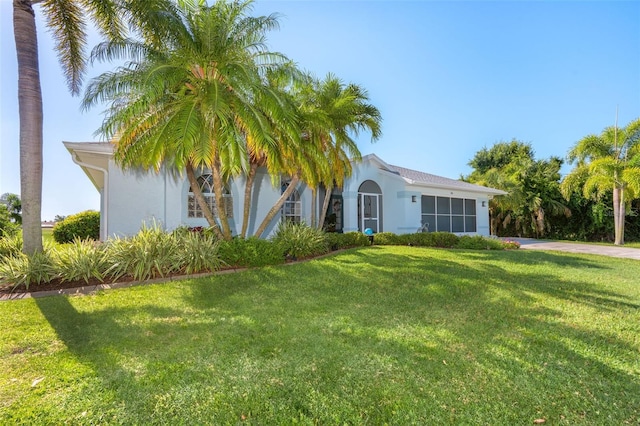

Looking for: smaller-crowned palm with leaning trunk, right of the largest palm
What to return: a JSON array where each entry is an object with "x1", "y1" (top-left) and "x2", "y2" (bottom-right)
[{"x1": 250, "y1": 74, "x2": 382, "y2": 236}]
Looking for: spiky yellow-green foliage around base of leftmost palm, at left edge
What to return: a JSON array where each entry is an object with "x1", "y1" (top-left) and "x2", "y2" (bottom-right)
[{"x1": 0, "y1": 250, "x2": 58, "y2": 290}]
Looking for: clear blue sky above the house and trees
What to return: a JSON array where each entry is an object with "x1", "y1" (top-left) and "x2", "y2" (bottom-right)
[{"x1": 0, "y1": 0, "x2": 640, "y2": 219}]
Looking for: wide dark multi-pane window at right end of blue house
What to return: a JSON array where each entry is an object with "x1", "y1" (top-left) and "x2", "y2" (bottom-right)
[{"x1": 422, "y1": 195, "x2": 476, "y2": 232}]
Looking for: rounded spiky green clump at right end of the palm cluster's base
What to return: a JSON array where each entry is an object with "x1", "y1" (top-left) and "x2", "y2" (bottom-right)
[{"x1": 272, "y1": 221, "x2": 329, "y2": 259}]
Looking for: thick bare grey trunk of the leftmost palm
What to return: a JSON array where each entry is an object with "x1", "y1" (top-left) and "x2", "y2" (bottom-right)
[{"x1": 13, "y1": 0, "x2": 43, "y2": 254}]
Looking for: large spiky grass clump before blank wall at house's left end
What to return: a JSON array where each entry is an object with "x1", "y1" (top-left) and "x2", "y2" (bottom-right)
[{"x1": 105, "y1": 225, "x2": 181, "y2": 280}]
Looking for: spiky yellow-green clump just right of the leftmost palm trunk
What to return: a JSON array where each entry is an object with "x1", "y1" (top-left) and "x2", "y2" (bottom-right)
[{"x1": 54, "y1": 238, "x2": 107, "y2": 284}]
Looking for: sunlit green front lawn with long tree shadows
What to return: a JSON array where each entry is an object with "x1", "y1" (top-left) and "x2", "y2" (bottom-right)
[{"x1": 0, "y1": 246, "x2": 640, "y2": 425}]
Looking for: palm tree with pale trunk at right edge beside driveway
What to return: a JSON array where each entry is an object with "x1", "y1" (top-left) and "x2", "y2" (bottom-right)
[{"x1": 561, "y1": 119, "x2": 640, "y2": 245}]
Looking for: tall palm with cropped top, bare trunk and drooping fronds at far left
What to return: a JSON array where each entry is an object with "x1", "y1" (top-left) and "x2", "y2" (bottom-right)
[{"x1": 13, "y1": 0, "x2": 175, "y2": 253}]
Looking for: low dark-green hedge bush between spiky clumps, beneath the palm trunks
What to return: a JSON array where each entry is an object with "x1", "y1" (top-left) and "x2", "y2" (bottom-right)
[{"x1": 219, "y1": 237, "x2": 284, "y2": 268}]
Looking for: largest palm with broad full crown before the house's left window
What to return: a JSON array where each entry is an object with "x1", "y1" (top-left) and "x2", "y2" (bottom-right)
[{"x1": 84, "y1": 1, "x2": 287, "y2": 239}]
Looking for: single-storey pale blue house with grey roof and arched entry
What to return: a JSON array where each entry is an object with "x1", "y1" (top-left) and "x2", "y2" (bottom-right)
[{"x1": 64, "y1": 142, "x2": 505, "y2": 239}]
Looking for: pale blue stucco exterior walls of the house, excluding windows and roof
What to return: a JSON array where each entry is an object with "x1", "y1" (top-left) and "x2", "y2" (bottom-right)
[{"x1": 102, "y1": 156, "x2": 496, "y2": 237}]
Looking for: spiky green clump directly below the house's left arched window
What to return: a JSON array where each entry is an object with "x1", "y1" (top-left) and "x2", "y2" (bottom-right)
[{"x1": 173, "y1": 232, "x2": 223, "y2": 274}]
